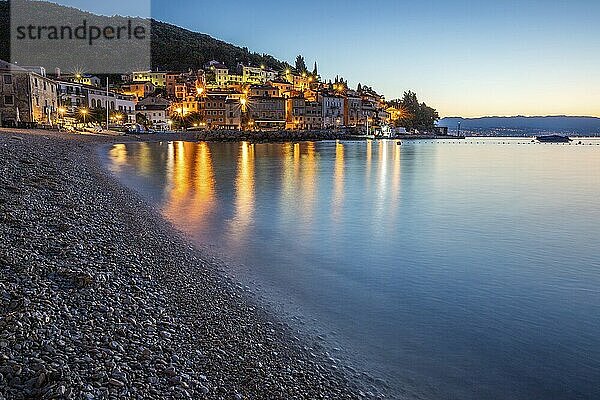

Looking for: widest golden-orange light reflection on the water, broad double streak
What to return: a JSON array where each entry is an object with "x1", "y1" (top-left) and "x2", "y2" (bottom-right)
[{"x1": 163, "y1": 142, "x2": 217, "y2": 230}]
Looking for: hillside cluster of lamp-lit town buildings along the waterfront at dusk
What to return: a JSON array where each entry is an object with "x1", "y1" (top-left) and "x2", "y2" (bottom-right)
[{"x1": 0, "y1": 57, "x2": 400, "y2": 131}]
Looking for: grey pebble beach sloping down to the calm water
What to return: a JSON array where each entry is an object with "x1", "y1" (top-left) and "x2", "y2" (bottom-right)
[{"x1": 0, "y1": 129, "x2": 380, "y2": 399}]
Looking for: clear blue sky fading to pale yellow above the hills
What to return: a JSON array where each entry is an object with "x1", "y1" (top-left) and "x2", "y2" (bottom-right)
[{"x1": 43, "y1": 0, "x2": 600, "y2": 117}]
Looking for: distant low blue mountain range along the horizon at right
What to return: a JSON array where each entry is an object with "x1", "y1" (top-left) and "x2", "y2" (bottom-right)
[{"x1": 438, "y1": 115, "x2": 600, "y2": 136}]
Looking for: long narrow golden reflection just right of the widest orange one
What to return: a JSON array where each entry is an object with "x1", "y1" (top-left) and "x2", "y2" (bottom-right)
[{"x1": 229, "y1": 142, "x2": 256, "y2": 244}]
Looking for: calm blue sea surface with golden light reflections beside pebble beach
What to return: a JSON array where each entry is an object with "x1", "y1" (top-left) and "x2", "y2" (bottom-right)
[{"x1": 106, "y1": 139, "x2": 600, "y2": 400}]
